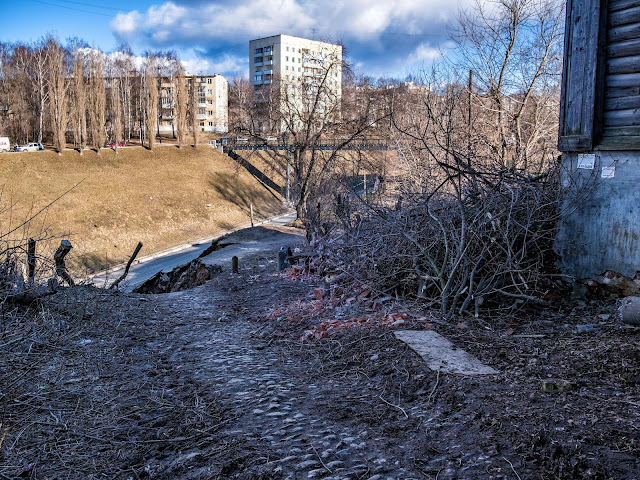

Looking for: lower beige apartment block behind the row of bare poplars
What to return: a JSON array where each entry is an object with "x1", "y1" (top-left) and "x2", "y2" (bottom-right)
[{"x1": 158, "y1": 75, "x2": 229, "y2": 133}]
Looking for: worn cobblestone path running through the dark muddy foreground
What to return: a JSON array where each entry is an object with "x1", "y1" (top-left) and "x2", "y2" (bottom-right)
[{"x1": 148, "y1": 283, "x2": 422, "y2": 480}]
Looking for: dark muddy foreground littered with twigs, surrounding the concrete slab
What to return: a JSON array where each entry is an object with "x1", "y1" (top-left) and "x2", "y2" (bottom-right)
[{"x1": 0, "y1": 229, "x2": 640, "y2": 480}]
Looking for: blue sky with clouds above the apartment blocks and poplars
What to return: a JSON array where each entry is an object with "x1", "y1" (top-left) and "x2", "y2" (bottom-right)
[{"x1": 5, "y1": 0, "x2": 470, "y2": 78}]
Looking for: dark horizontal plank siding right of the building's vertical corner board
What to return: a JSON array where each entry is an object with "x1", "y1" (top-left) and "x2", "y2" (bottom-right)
[{"x1": 602, "y1": 0, "x2": 640, "y2": 141}]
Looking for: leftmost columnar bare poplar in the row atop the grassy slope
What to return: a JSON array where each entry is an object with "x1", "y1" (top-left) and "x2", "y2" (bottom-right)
[{"x1": 46, "y1": 37, "x2": 69, "y2": 155}]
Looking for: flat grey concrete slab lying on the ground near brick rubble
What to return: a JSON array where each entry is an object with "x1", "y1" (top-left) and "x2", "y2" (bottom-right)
[{"x1": 394, "y1": 330, "x2": 498, "y2": 375}]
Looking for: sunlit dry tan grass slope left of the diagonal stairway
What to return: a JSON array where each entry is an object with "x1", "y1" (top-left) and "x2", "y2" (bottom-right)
[{"x1": 0, "y1": 145, "x2": 282, "y2": 271}]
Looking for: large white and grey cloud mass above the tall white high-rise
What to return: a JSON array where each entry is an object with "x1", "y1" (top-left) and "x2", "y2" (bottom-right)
[{"x1": 111, "y1": 0, "x2": 474, "y2": 75}]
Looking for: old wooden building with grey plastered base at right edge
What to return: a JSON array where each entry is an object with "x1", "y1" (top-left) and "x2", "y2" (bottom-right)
[{"x1": 555, "y1": 0, "x2": 640, "y2": 286}]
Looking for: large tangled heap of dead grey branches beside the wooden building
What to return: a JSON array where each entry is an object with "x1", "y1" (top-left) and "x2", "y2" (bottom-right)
[{"x1": 318, "y1": 167, "x2": 559, "y2": 315}]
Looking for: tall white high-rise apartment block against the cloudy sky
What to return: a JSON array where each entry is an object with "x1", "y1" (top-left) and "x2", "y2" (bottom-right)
[{"x1": 249, "y1": 35, "x2": 342, "y2": 130}]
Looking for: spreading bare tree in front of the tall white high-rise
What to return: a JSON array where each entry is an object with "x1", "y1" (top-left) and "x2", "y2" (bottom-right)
[{"x1": 235, "y1": 51, "x2": 389, "y2": 221}]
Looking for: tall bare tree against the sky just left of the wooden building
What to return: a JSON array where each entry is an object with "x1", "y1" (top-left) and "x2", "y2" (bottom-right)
[{"x1": 452, "y1": 0, "x2": 564, "y2": 170}]
